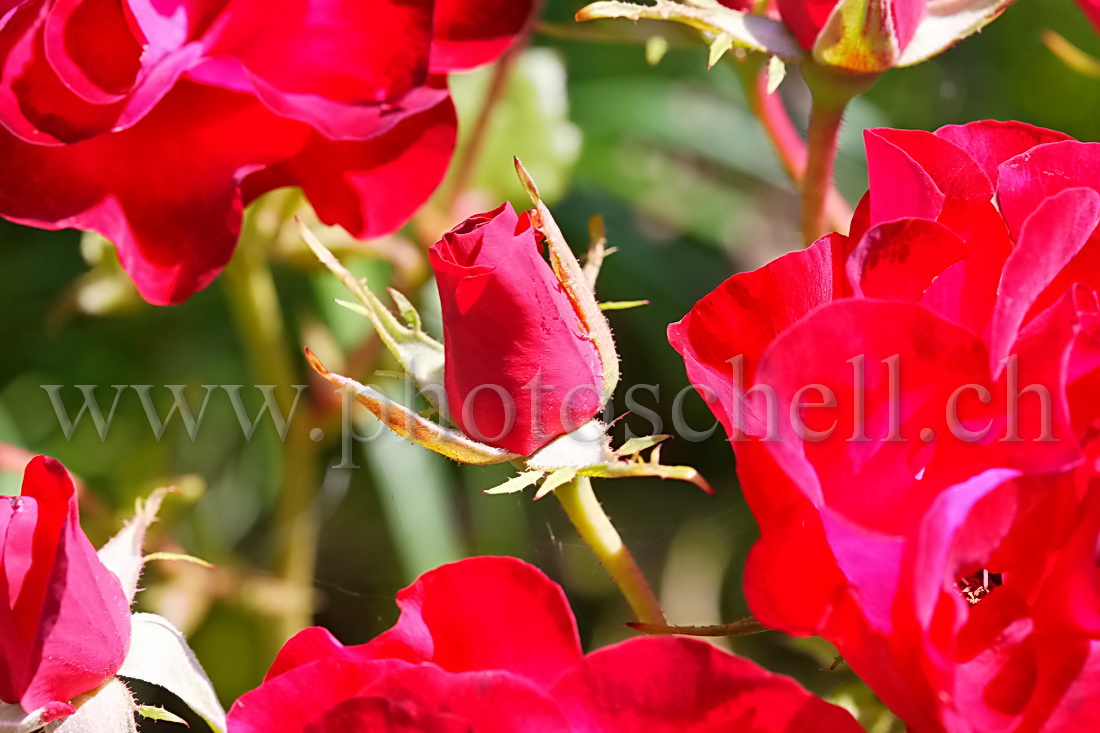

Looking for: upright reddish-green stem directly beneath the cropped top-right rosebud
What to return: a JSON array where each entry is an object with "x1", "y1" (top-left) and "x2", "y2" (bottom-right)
[{"x1": 802, "y1": 64, "x2": 878, "y2": 247}]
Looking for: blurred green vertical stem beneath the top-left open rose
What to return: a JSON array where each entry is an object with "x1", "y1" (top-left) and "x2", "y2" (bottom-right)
[{"x1": 222, "y1": 200, "x2": 317, "y2": 649}]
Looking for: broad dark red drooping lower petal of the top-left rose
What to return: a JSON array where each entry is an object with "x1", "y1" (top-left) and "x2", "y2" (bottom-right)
[{"x1": 0, "y1": 83, "x2": 308, "y2": 304}]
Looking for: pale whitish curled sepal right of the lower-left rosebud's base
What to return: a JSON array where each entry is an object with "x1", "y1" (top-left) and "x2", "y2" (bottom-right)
[{"x1": 118, "y1": 613, "x2": 226, "y2": 733}]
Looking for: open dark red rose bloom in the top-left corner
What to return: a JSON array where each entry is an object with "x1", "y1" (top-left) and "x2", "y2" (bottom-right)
[{"x1": 0, "y1": 0, "x2": 535, "y2": 304}]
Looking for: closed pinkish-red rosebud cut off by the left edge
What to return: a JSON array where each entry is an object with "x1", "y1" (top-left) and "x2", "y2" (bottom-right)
[{"x1": 0, "y1": 457, "x2": 130, "y2": 722}]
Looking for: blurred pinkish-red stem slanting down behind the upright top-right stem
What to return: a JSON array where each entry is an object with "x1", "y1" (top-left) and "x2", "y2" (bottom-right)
[{"x1": 727, "y1": 54, "x2": 851, "y2": 233}]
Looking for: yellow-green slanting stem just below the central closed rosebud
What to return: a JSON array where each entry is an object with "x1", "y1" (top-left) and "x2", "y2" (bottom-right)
[{"x1": 554, "y1": 475, "x2": 666, "y2": 626}]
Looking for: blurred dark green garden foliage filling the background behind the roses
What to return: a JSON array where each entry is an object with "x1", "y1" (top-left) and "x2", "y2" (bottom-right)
[{"x1": 0, "y1": 0, "x2": 1100, "y2": 730}]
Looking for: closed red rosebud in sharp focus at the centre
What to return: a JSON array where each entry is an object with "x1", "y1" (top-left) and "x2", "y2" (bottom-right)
[{"x1": 429, "y1": 204, "x2": 603, "y2": 456}]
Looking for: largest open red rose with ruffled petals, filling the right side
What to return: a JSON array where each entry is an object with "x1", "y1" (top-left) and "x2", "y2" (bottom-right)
[{"x1": 669, "y1": 122, "x2": 1100, "y2": 731}]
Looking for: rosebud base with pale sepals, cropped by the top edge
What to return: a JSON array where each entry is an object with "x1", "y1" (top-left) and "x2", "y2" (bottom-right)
[{"x1": 777, "y1": 0, "x2": 1013, "y2": 73}]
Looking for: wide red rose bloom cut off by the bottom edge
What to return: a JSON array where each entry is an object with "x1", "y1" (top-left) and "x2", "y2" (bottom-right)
[{"x1": 229, "y1": 557, "x2": 860, "y2": 733}]
